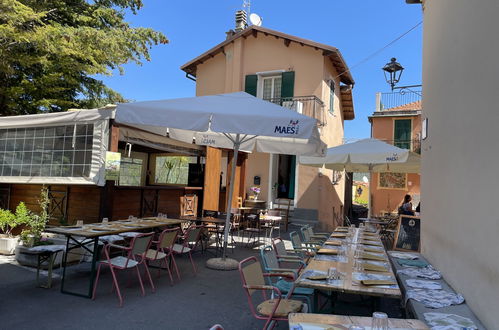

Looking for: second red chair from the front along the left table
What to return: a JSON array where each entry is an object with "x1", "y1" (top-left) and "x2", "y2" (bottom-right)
[{"x1": 145, "y1": 227, "x2": 180, "y2": 285}]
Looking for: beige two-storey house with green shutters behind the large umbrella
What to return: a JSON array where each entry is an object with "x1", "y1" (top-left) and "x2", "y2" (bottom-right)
[{"x1": 181, "y1": 26, "x2": 354, "y2": 227}]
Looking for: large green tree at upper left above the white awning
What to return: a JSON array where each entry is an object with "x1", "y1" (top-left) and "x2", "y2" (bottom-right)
[{"x1": 0, "y1": 0, "x2": 168, "y2": 115}]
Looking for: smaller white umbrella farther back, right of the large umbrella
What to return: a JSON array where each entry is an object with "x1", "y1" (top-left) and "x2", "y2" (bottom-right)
[{"x1": 300, "y1": 139, "x2": 420, "y2": 216}]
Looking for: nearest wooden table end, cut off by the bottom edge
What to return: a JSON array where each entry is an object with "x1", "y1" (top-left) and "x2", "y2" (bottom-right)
[{"x1": 288, "y1": 313, "x2": 429, "y2": 330}]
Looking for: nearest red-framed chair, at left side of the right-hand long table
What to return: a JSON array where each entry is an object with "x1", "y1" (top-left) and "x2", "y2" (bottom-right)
[{"x1": 239, "y1": 257, "x2": 307, "y2": 329}]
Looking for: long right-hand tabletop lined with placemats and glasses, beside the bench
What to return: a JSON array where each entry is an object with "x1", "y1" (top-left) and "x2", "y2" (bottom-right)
[{"x1": 296, "y1": 227, "x2": 401, "y2": 298}]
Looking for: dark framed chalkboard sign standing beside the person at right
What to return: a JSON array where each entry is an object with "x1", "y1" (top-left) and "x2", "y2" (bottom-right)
[{"x1": 393, "y1": 215, "x2": 421, "y2": 252}]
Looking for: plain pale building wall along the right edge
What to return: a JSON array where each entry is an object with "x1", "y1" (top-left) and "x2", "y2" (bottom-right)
[{"x1": 421, "y1": 0, "x2": 499, "y2": 329}]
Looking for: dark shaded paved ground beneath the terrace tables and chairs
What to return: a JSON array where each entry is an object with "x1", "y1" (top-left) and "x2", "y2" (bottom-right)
[{"x1": 0, "y1": 227, "x2": 400, "y2": 330}]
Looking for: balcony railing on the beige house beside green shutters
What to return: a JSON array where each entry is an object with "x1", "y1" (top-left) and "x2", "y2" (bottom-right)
[{"x1": 266, "y1": 95, "x2": 327, "y2": 126}]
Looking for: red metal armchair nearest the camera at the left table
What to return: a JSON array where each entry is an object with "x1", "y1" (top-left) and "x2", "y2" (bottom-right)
[{"x1": 92, "y1": 233, "x2": 155, "y2": 307}]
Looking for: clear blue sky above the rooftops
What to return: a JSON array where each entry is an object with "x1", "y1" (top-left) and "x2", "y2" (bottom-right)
[{"x1": 100, "y1": 0, "x2": 422, "y2": 139}]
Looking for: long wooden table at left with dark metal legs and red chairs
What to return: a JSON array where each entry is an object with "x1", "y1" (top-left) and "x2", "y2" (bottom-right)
[{"x1": 45, "y1": 217, "x2": 184, "y2": 298}]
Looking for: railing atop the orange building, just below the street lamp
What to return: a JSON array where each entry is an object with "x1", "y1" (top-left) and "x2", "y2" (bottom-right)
[{"x1": 376, "y1": 90, "x2": 421, "y2": 111}]
